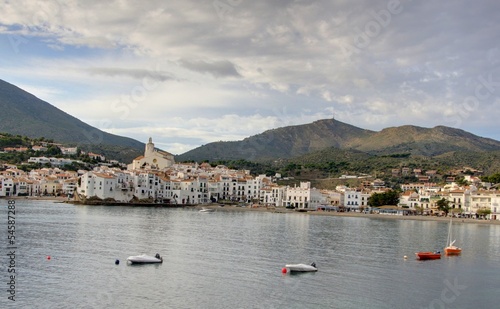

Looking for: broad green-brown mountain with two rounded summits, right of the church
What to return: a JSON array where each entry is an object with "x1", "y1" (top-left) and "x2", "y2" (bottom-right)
[{"x1": 177, "y1": 119, "x2": 500, "y2": 161}]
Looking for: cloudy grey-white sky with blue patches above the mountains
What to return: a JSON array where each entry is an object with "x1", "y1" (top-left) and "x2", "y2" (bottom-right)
[{"x1": 0, "y1": 0, "x2": 500, "y2": 154}]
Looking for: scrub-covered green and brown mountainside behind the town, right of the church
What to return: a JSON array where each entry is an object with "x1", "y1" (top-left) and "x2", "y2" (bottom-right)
[{"x1": 177, "y1": 119, "x2": 500, "y2": 165}]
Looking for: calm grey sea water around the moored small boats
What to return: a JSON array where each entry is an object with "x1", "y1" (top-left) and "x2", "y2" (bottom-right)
[{"x1": 0, "y1": 200, "x2": 500, "y2": 308}]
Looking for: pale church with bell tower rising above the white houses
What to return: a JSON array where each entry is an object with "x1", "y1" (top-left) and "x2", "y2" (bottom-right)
[{"x1": 127, "y1": 137, "x2": 175, "y2": 171}]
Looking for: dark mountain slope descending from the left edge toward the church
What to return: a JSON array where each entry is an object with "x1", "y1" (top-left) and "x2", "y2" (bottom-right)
[{"x1": 0, "y1": 80, "x2": 144, "y2": 161}]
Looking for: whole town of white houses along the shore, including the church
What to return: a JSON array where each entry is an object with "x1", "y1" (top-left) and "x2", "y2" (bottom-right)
[{"x1": 0, "y1": 138, "x2": 500, "y2": 220}]
